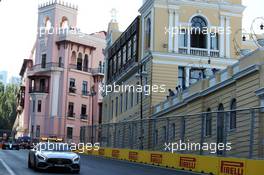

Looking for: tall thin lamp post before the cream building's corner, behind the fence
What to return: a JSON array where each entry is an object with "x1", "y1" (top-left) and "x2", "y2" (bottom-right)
[{"x1": 136, "y1": 64, "x2": 148, "y2": 150}]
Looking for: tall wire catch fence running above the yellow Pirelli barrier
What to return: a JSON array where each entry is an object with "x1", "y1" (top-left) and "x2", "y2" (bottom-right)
[{"x1": 84, "y1": 108, "x2": 264, "y2": 159}]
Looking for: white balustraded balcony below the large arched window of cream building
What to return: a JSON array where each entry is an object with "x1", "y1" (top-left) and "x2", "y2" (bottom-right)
[{"x1": 179, "y1": 47, "x2": 220, "y2": 58}]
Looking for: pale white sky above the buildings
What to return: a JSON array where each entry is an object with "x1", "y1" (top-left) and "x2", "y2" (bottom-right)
[{"x1": 0, "y1": 0, "x2": 264, "y2": 77}]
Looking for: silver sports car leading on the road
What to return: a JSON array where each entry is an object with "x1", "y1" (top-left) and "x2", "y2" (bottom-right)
[{"x1": 28, "y1": 142, "x2": 80, "y2": 174}]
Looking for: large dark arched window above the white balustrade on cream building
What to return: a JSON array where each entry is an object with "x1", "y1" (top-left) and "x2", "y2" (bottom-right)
[{"x1": 191, "y1": 16, "x2": 207, "y2": 49}]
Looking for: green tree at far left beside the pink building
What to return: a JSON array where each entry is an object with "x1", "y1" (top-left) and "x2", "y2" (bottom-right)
[{"x1": 0, "y1": 84, "x2": 19, "y2": 130}]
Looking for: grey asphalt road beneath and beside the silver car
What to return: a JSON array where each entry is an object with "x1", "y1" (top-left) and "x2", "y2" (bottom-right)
[{"x1": 0, "y1": 150, "x2": 202, "y2": 175}]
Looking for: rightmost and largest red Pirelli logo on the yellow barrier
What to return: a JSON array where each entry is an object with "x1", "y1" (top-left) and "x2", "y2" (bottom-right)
[{"x1": 220, "y1": 161, "x2": 245, "y2": 175}]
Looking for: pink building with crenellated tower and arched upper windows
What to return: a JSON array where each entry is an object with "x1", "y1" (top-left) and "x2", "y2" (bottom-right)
[{"x1": 14, "y1": 1, "x2": 106, "y2": 142}]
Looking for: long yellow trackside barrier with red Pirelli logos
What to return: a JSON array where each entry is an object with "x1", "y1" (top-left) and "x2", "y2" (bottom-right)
[{"x1": 76, "y1": 148, "x2": 264, "y2": 175}]
